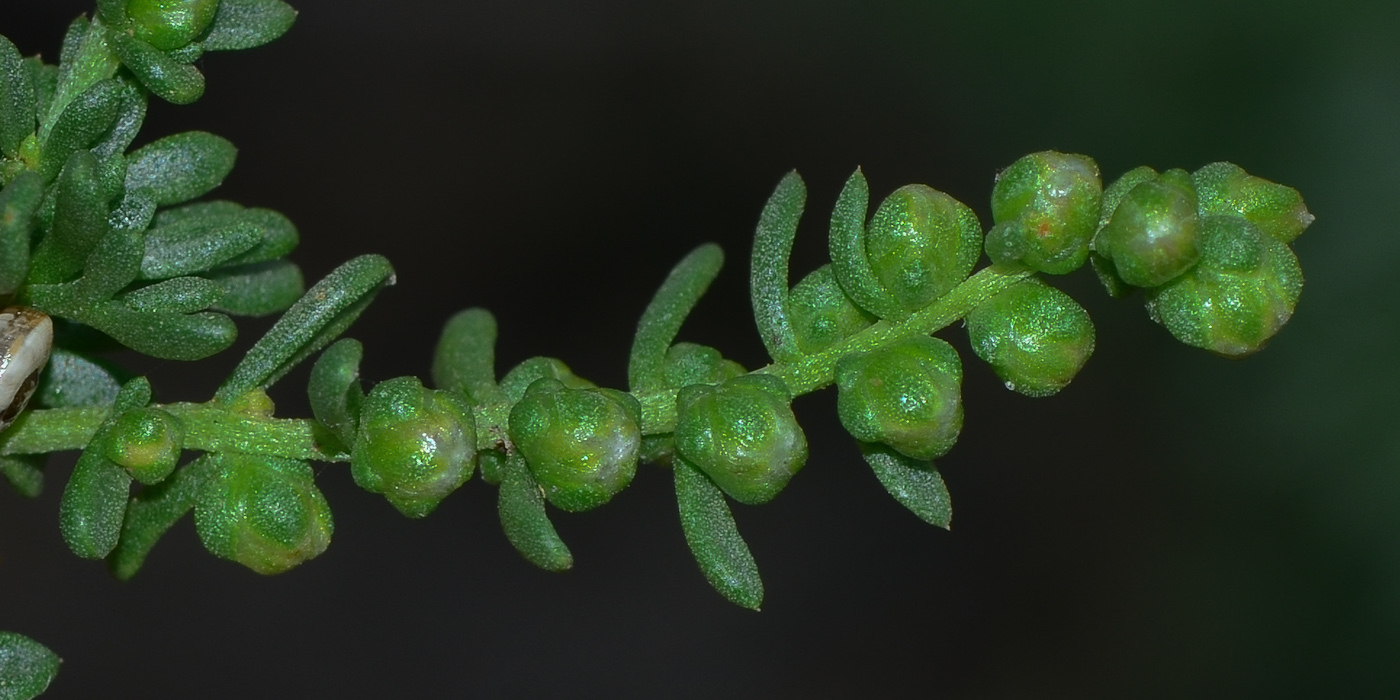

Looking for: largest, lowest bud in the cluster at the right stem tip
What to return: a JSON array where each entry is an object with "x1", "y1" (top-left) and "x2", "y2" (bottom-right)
[{"x1": 1148, "y1": 216, "x2": 1303, "y2": 357}]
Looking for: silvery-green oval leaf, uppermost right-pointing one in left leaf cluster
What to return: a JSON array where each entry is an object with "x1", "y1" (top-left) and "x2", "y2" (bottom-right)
[{"x1": 126, "y1": 132, "x2": 238, "y2": 206}]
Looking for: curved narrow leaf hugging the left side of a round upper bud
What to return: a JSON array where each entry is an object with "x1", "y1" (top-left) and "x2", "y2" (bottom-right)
[{"x1": 827, "y1": 168, "x2": 909, "y2": 319}]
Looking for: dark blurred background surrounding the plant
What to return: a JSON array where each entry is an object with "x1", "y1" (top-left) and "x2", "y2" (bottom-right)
[{"x1": 0, "y1": 0, "x2": 1400, "y2": 699}]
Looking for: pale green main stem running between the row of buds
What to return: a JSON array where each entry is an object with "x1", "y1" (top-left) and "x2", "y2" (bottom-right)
[{"x1": 0, "y1": 266, "x2": 1032, "y2": 462}]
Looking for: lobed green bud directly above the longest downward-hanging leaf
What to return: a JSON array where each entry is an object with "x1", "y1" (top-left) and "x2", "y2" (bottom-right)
[{"x1": 675, "y1": 374, "x2": 806, "y2": 505}]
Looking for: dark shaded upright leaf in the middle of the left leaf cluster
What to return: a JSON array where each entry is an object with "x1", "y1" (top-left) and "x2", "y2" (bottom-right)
[{"x1": 29, "y1": 151, "x2": 107, "y2": 284}]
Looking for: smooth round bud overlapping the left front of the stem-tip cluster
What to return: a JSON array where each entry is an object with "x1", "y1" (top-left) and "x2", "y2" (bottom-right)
[{"x1": 1093, "y1": 169, "x2": 1201, "y2": 287}]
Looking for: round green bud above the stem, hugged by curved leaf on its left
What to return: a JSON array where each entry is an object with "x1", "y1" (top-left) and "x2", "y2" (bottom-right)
[{"x1": 865, "y1": 185, "x2": 981, "y2": 311}]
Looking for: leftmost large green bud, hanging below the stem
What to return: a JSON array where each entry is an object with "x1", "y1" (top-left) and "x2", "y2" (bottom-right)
[{"x1": 195, "y1": 452, "x2": 335, "y2": 574}]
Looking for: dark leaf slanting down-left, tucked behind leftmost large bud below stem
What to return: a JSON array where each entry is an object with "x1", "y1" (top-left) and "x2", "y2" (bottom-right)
[{"x1": 108, "y1": 455, "x2": 218, "y2": 581}]
